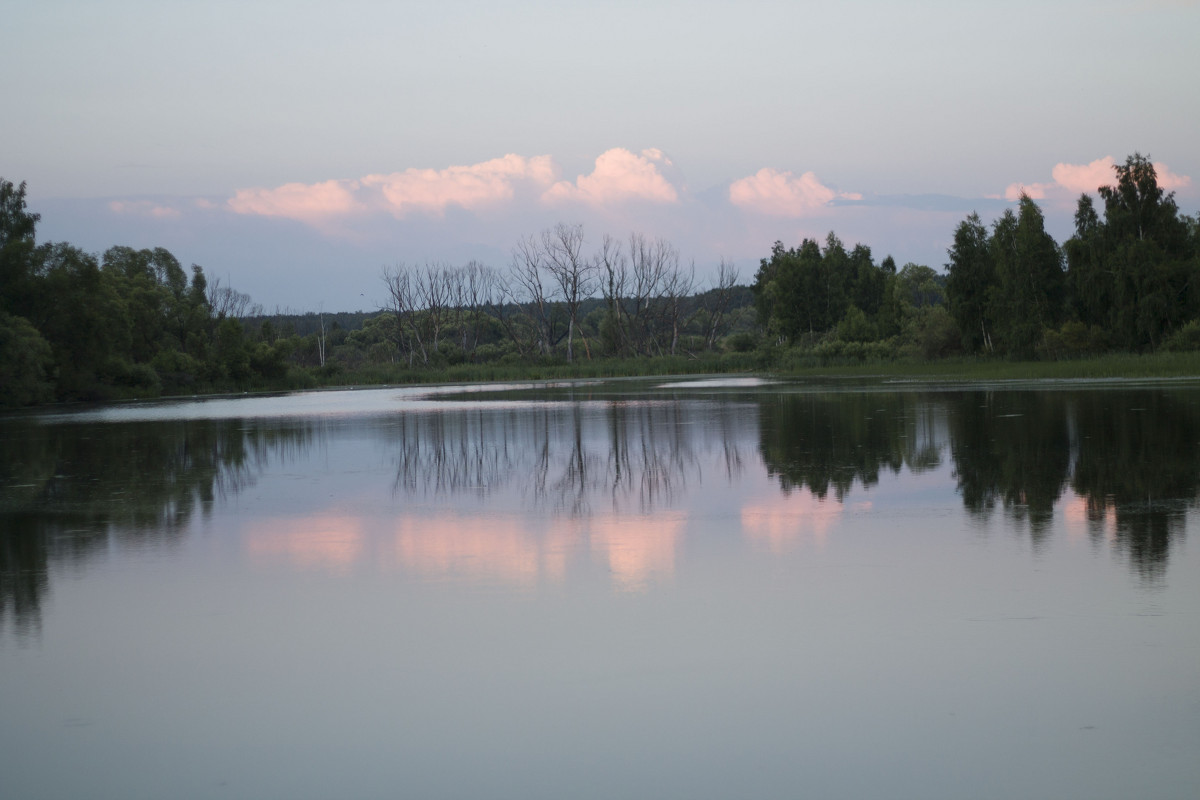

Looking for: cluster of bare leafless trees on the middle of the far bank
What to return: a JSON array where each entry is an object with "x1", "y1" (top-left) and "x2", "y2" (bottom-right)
[{"x1": 374, "y1": 223, "x2": 750, "y2": 366}]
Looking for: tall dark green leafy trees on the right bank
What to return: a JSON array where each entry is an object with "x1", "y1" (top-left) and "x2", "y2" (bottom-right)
[{"x1": 752, "y1": 154, "x2": 1200, "y2": 359}]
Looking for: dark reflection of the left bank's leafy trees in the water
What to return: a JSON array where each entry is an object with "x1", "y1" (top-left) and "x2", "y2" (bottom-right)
[{"x1": 0, "y1": 420, "x2": 313, "y2": 634}]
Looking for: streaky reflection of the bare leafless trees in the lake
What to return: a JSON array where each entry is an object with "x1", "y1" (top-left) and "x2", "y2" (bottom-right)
[{"x1": 394, "y1": 401, "x2": 754, "y2": 516}]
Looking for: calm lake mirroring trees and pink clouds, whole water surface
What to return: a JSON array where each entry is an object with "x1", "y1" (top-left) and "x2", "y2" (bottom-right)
[{"x1": 0, "y1": 378, "x2": 1200, "y2": 800}]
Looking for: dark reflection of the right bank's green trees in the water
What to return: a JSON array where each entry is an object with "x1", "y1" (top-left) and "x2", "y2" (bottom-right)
[{"x1": 760, "y1": 389, "x2": 1200, "y2": 582}]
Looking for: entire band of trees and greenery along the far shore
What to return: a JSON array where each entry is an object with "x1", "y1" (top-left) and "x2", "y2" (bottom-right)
[{"x1": 0, "y1": 154, "x2": 1200, "y2": 408}]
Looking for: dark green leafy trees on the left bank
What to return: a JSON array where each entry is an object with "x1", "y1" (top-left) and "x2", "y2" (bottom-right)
[{"x1": 0, "y1": 179, "x2": 297, "y2": 405}]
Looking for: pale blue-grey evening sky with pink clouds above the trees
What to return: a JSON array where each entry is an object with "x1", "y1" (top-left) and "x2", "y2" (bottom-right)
[{"x1": 0, "y1": 0, "x2": 1200, "y2": 312}]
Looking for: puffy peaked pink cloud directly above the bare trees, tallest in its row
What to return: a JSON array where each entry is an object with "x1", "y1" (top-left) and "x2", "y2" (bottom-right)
[{"x1": 542, "y1": 148, "x2": 679, "y2": 205}]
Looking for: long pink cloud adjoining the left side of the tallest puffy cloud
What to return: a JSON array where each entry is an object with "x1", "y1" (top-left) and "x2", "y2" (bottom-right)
[{"x1": 362, "y1": 154, "x2": 558, "y2": 217}]
